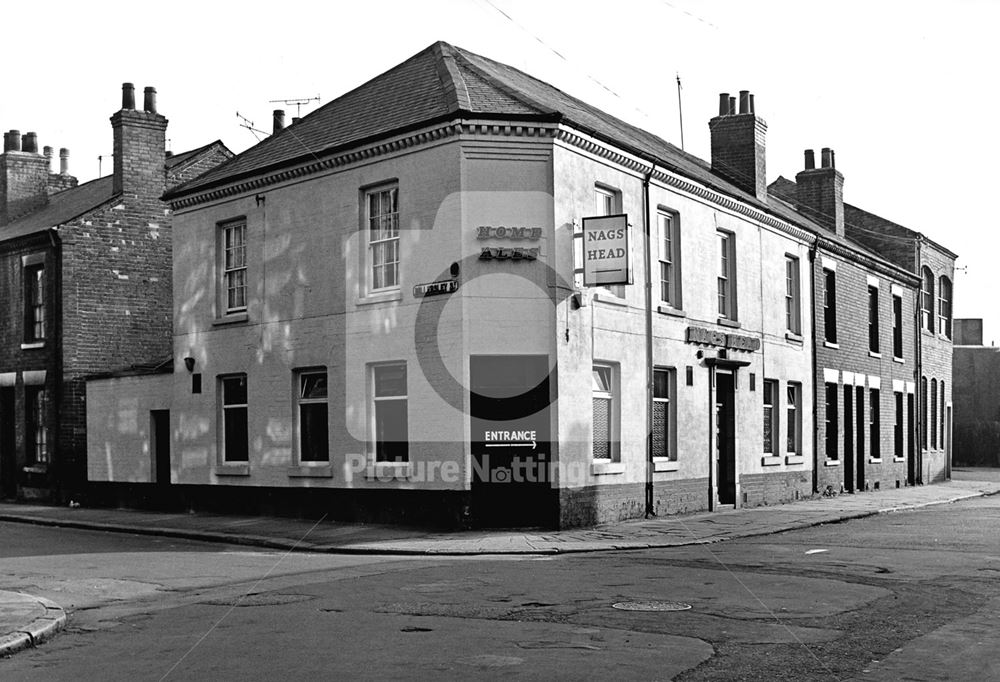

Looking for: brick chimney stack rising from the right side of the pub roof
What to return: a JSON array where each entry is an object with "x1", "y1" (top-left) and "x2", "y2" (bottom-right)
[{"x1": 708, "y1": 90, "x2": 767, "y2": 201}]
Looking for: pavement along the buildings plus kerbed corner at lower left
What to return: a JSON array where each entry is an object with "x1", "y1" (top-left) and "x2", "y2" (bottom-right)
[{"x1": 0, "y1": 469, "x2": 1000, "y2": 656}]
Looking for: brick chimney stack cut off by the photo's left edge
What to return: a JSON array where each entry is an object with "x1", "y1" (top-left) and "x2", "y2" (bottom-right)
[{"x1": 0, "y1": 130, "x2": 49, "y2": 227}]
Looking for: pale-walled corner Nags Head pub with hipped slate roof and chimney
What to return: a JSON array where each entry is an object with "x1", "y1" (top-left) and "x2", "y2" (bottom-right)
[{"x1": 88, "y1": 42, "x2": 936, "y2": 527}]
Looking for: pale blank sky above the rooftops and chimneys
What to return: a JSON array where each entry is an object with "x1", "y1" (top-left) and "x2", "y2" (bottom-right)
[{"x1": 0, "y1": 0, "x2": 1000, "y2": 344}]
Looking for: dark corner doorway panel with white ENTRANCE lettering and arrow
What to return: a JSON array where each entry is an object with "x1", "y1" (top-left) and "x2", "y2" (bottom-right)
[{"x1": 469, "y1": 355, "x2": 556, "y2": 528}]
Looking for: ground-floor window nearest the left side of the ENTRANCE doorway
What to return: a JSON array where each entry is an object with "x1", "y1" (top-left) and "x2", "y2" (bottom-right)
[{"x1": 371, "y1": 362, "x2": 410, "y2": 462}]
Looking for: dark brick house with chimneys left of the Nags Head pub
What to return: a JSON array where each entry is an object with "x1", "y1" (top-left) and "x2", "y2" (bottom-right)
[{"x1": 0, "y1": 84, "x2": 232, "y2": 501}]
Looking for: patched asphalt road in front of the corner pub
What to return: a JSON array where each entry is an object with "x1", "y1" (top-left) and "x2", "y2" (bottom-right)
[{"x1": 0, "y1": 497, "x2": 1000, "y2": 682}]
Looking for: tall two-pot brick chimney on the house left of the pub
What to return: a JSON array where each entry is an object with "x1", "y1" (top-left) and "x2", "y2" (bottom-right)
[{"x1": 111, "y1": 83, "x2": 167, "y2": 201}]
